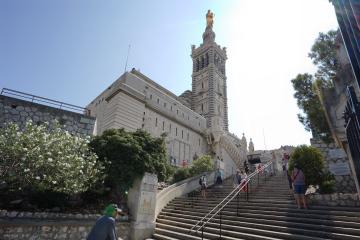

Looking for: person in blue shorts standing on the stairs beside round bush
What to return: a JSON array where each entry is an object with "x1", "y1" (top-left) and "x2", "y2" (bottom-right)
[{"x1": 291, "y1": 164, "x2": 307, "y2": 209}]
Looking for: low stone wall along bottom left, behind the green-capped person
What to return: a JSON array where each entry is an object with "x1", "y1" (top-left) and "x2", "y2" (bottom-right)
[{"x1": 0, "y1": 210, "x2": 130, "y2": 240}]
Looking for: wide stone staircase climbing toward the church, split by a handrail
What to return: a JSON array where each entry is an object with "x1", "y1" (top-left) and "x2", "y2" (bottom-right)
[{"x1": 153, "y1": 175, "x2": 360, "y2": 240}]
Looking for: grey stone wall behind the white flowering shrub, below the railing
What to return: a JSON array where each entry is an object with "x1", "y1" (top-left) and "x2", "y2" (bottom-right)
[{"x1": 0, "y1": 95, "x2": 95, "y2": 135}]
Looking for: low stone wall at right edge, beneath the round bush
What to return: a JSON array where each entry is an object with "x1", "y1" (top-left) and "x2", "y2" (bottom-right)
[{"x1": 307, "y1": 193, "x2": 360, "y2": 207}]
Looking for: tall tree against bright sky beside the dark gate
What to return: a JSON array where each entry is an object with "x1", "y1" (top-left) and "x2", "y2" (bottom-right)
[{"x1": 291, "y1": 31, "x2": 338, "y2": 143}]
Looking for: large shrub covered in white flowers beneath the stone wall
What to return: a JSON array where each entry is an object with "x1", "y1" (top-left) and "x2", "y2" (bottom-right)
[{"x1": 0, "y1": 121, "x2": 103, "y2": 194}]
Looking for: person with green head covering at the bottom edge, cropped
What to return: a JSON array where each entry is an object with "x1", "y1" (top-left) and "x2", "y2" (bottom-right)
[{"x1": 86, "y1": 204, "x2": 122, "y2": 240}]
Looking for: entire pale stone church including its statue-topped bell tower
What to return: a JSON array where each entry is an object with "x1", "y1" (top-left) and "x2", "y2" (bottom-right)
[{"x1": 87, "y1": 10, "x2": 247, "y2": 176}]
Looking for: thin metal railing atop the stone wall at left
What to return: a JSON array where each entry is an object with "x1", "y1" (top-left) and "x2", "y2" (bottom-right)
[{"x1": 0, "y1": 88, "x2": 90, "y2": 116}]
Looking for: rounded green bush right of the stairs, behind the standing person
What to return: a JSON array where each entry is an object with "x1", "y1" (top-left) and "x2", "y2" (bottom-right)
[{"x1": 289, "y1": 145, "x2": 324, "y2": 186}]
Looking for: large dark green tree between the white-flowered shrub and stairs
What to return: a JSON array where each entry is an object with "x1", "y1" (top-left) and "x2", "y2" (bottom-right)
[{"x1": 90, "y1": 129, "x2": 170, "y2": 198}]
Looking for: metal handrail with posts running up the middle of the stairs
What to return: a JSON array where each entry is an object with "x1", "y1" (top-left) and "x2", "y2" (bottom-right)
[{"x1": 189, "y1": 161, "x2": 272, "y2": 239}]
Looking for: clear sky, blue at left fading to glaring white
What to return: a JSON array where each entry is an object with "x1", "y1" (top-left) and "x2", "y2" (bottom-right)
[{"x1": 0, "y1": 0, "x2": 338, "y2": 149}]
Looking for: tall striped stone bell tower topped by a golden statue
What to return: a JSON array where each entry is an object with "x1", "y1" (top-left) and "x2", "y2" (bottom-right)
[{"x1": 191, "y1": 10, "x2": 229, "y2": 131}]
